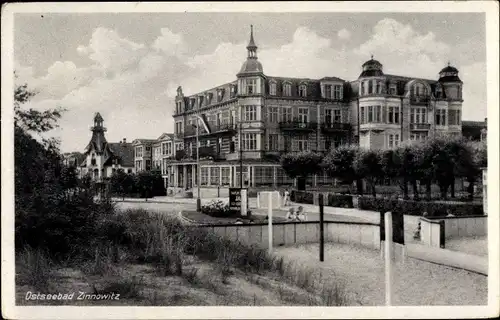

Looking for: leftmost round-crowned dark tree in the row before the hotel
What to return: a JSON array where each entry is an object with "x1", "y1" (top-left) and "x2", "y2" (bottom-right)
[{"x1": 280, "y1": 151, "x2": 323, "y2": 189}]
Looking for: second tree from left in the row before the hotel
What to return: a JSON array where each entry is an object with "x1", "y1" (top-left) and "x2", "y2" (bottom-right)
[{"x1": 322, "y1": 145, "x2": 363, "y2": 194}]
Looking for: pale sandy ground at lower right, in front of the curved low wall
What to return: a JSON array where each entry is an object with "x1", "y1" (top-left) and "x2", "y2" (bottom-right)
[{"x1": 275, "y1": 244, "x2": 488, "y2": 306}]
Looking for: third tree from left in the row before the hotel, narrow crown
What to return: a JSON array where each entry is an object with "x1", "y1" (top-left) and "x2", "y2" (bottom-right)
[{"x1": 353, "y1": 149, "x2": 383, "y2": 198}]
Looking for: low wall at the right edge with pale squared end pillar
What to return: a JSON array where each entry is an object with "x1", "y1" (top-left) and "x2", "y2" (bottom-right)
[{"x1": 420, "y1": 216, "x2": 488, "y2": 248}]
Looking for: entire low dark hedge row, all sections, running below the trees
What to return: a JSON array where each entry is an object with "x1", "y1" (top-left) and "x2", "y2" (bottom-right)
[{"x1": 290, "y1": 190, "x2": 484, "y2": 217}]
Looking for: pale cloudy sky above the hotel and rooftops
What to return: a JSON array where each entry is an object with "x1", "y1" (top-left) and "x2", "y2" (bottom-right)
[{"x1": 14, "y1": 12, "x2": 487, "y2": 152}]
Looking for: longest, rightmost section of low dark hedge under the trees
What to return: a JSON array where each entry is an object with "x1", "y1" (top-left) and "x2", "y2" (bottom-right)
[{"x1": 359, "y1": 197, "x2": 484, "y2": 217}]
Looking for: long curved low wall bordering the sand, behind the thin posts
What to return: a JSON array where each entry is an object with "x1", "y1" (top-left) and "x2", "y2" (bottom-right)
[{"x1": 198, "y1": 221, "x2": 380, "y2": 249}]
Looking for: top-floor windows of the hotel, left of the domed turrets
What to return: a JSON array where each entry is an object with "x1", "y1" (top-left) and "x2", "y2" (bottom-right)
[{"x1": 176, "y1": 79, "x2": 343, "y2": 113}]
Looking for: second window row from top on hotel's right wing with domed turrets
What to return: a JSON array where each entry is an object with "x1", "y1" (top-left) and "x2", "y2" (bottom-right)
[{"x1": 360, "y1": 106, "x2": 462, "y2": 126}]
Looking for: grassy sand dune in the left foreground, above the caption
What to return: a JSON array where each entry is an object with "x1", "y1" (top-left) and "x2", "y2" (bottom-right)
[{"x1": 16, "y1": 210, "x2": 349, "y2": 306}]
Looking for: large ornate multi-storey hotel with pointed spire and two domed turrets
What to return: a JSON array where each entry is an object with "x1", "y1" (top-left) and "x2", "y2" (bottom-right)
[{"x1": 164, "y1": 30, "x2": 463, "y2": 192}]
